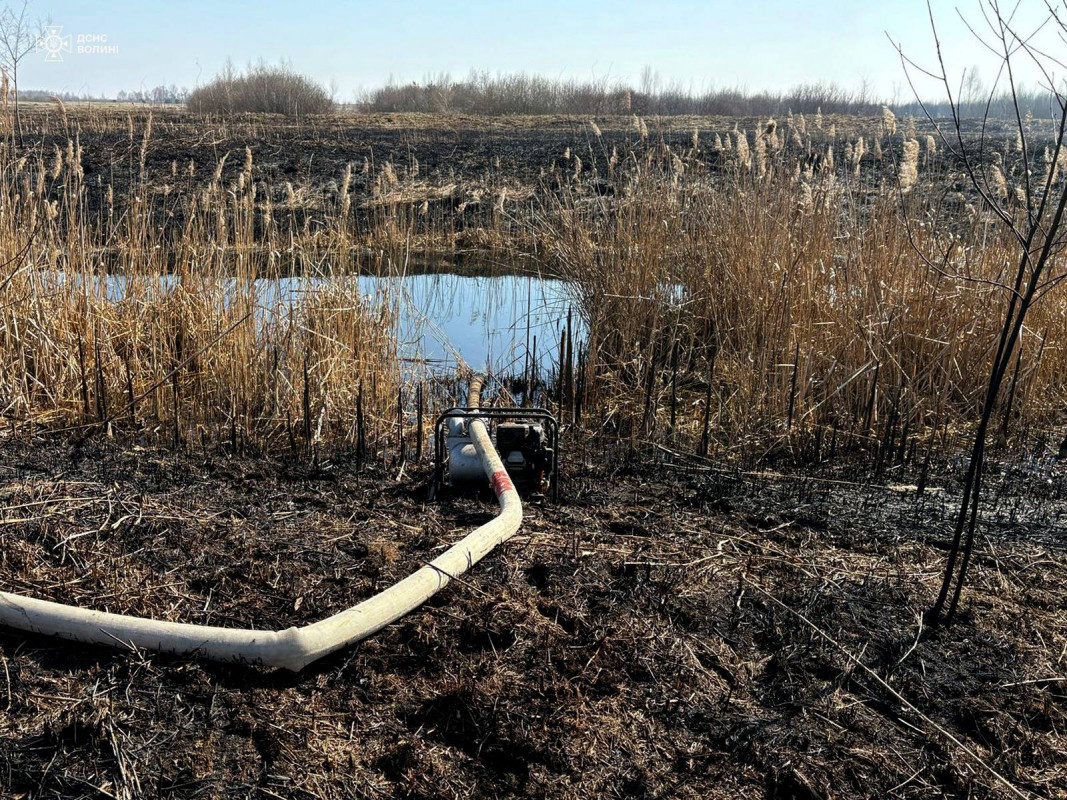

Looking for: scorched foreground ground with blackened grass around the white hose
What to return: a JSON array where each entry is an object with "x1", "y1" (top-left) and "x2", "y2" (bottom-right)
[{"x1": 0, "y1": 432, "x2": 1067, "y2": 798}]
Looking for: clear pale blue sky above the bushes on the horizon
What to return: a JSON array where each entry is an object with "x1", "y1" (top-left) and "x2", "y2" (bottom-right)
[{"x1": 20, "y1": 0, "x2": 1062, "y2": 100}]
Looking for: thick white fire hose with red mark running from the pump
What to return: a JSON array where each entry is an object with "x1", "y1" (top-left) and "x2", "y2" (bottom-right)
[{"x1": 0, "y1": 377, "x2": 523, "y2": 672}]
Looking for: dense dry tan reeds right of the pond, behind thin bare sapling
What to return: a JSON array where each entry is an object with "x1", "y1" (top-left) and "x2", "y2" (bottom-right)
[{"x1": 537, "y1": 128, "x2": 1067, "y2": 456}]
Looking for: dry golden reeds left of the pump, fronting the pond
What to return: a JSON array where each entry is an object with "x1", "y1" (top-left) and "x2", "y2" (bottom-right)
[{"x1": 0, "y1": 111, "x2": 400, "y2": 456}]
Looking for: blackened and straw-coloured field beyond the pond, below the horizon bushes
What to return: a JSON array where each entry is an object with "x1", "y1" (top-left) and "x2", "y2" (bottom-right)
[{"x1": 31, "y1": 109, "x2": 1044, "y2": 246}]
